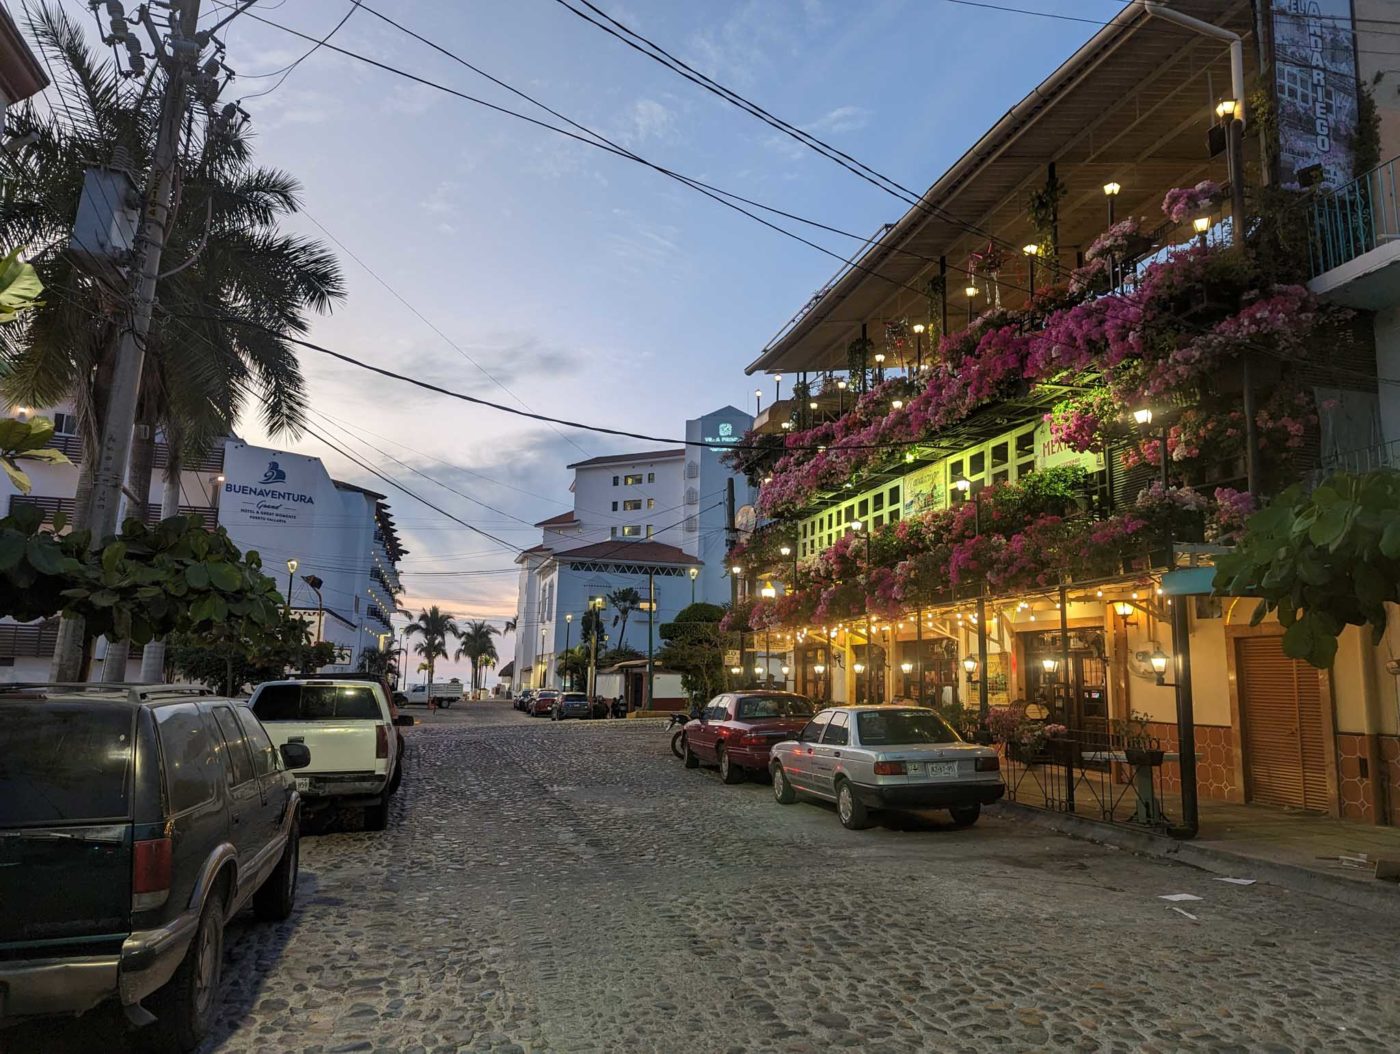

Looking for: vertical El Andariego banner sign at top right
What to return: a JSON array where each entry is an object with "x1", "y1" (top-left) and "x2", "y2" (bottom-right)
[{"x1": 1273, "y1": 0, "x2": 1357, "y2": 186}]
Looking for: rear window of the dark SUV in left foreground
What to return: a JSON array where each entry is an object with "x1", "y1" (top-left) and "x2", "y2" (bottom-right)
[{"x1": 0, "y1": 700, "x2": 136, "y2": 827}]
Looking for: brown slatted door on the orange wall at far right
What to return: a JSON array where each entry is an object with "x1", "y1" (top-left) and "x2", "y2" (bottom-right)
[{"x1": 1236, "y1": 637, "x2": 1329, "y2": 810}]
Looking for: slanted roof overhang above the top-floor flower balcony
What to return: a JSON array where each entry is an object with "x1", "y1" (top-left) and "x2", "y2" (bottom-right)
[{"x1": 745, "y1": 0, "x2": 1256, "y2": 374}]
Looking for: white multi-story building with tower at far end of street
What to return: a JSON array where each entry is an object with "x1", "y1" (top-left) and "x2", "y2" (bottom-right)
[{"x1": 511, "y1": 406, "x2": 753, "y2": 701}]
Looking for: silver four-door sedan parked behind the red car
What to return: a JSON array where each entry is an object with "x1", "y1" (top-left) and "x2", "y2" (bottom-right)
[{"x1": 769, "y1": 707, "x2": 1007, "y2": 830}]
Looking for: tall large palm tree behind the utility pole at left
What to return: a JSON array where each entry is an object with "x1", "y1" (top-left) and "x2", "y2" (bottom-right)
[{"x1": 0, "y1": 1, "x2": 344, "y2": 680}]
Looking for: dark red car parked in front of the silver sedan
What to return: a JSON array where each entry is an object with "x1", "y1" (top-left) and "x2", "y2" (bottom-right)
[{"x1": 685, "y1": 689, "x2": 816, "y2": 784}]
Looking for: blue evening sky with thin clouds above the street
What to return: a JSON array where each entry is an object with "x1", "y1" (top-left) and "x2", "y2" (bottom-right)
[{"x1": 70, "y1": 0, "x2": 1119, "y2": 674}]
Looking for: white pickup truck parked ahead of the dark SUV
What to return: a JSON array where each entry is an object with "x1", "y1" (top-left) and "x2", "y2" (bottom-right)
[{"x1": 248, "y1": 677, "x2": 413, "y2": 830}]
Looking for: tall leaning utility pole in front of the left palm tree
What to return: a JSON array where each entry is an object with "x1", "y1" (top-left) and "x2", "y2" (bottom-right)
[{"x1": 52, "y1": 0, "x2": 210, "y2": 682}]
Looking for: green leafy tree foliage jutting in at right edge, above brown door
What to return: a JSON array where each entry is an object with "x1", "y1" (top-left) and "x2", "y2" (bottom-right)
[{"x1": 1214, "y1": 469, "x2": 1400, "y2": 669}]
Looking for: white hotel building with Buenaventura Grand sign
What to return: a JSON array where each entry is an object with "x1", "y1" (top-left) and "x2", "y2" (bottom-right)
[{"x1": 0, "y1": 407, "x2": 405, "y2": 682}]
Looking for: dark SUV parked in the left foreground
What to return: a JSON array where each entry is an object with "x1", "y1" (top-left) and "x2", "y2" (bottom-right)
[{"x1": 0, "y1": 684, "x2": 311, "y2": 1051}]
